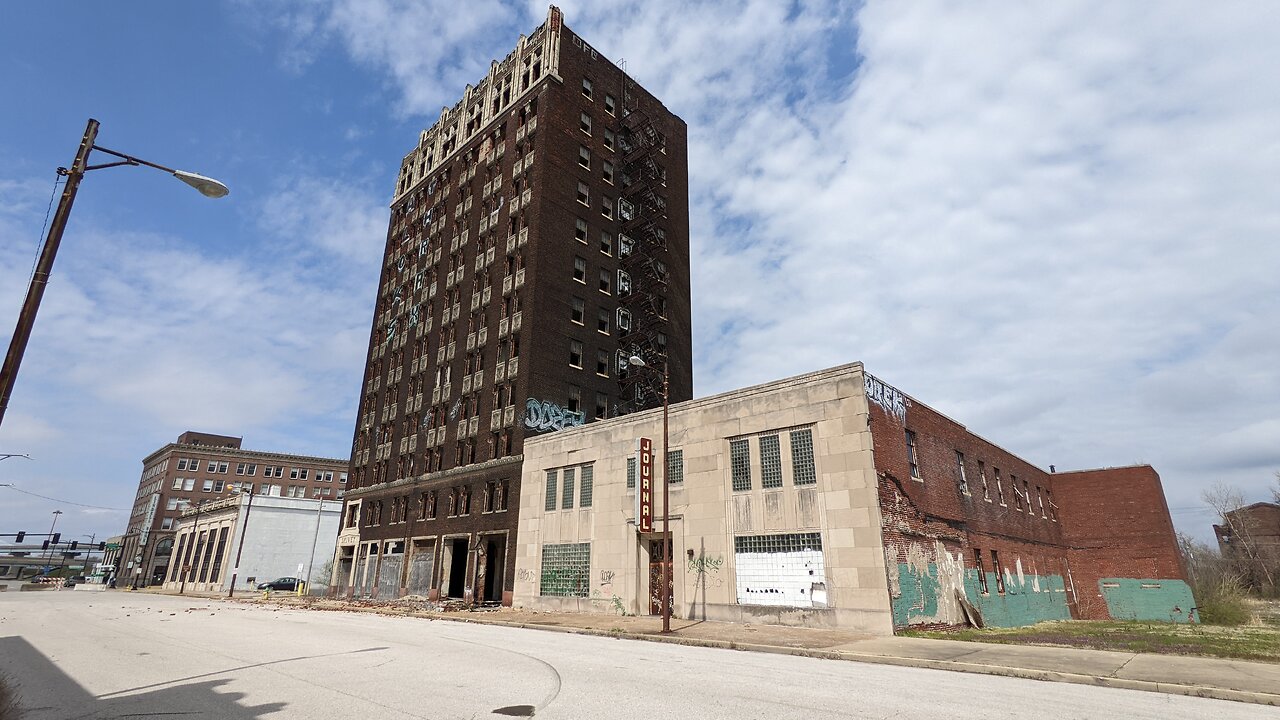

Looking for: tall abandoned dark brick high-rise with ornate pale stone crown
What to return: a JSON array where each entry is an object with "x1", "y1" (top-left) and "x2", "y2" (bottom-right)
[{"x1": 334, "y1": 6, "x2": 692, "y2": 603}]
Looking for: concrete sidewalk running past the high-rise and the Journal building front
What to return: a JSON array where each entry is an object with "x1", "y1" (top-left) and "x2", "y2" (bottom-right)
[{"x1": 129, "y1": 591, "x2": 1280, "y2": 706}]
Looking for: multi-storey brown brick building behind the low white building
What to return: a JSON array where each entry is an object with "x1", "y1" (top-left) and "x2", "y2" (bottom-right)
[{"x1": 116, "y1": 430, "x2": 347, "y2": 585}]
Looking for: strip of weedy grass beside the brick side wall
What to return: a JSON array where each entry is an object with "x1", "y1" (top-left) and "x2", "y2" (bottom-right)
[{"x1": 902, "y1": 620, "x2": 1280, "y2": 662}]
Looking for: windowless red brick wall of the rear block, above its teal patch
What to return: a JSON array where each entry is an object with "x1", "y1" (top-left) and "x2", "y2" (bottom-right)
[{"x1": 1053, "y1": 465, "x2": 1187, "y2": 619}]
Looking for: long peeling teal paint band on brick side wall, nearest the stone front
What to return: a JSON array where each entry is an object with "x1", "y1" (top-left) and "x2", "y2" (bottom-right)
[{"x1": 892, "y1": 562, "x2": 1071, "y2": 628}]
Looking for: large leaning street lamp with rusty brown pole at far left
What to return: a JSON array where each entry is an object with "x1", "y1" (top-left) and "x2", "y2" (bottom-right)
[{"x1": 0, "y1": 118, "x2": 229, "y2": 423}]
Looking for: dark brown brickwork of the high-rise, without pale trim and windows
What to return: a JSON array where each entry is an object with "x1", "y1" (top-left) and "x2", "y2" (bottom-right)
[{"x1": 340, "y1": 14, "x2": 692, "y2": 601}]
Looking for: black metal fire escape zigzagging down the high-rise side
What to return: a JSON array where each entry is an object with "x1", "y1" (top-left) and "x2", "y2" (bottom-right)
[{"x1": 614, "y1": 77, "x2": 669, "y2": 414}]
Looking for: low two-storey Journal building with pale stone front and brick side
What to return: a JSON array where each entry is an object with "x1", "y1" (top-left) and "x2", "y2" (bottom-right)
[{"x1": 515, "y1": 364, "x2": 1194, "y2": 633}]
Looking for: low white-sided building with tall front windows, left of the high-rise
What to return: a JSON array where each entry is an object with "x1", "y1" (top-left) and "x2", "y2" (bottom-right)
[{"x1": 164, "y1": 493, "x2": 342, "y2": 592}]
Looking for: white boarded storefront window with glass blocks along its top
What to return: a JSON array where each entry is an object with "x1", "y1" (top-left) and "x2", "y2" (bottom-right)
[{"x1": 733, "y1": 533, "x2": 827, "y2": 607}]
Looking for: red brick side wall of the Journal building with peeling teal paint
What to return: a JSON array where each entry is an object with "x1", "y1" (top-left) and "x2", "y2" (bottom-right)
[{"x1": 868, "y1": 375, "x2": 1194, "y2": 626}]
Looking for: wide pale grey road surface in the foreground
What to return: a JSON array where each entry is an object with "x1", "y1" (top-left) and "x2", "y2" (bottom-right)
[{"x1": 0, "y1": 585, "x2": 1280, "y2": 720}]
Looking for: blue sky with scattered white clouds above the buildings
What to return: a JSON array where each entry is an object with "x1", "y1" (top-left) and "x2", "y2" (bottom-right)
[{"x1": 0, "y1": 0, "x2": 1280, "y2": 538}]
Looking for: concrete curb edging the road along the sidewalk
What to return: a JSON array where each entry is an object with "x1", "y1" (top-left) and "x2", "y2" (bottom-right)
[{"x1": 192, "y1": 598, "x2": 1280, "y2": 707}]
